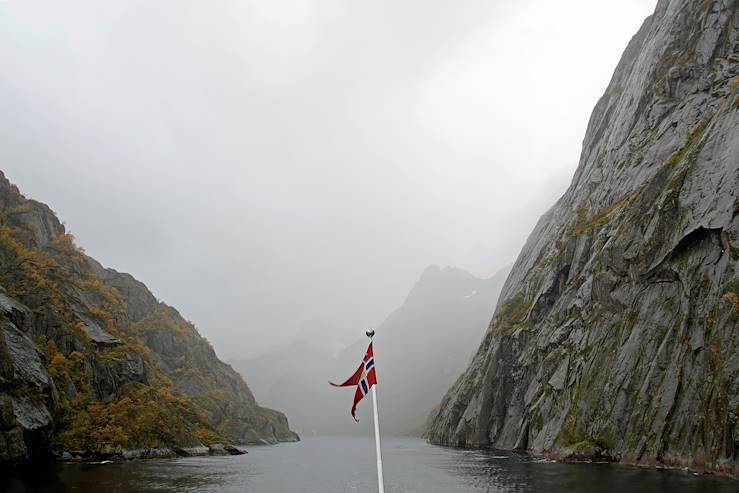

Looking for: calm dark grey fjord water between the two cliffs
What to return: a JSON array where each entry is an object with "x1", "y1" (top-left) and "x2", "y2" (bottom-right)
[{"x1": 0, "y1": 437, "x2": 739, "y2": 493}]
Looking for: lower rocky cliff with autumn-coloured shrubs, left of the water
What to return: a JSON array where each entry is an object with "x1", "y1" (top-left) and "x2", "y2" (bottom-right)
[{"x1": 0, "y1": 172, "x2": 297, "y2": 463}]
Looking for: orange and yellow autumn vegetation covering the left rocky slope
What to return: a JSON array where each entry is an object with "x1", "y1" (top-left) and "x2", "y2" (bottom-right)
[{"x1": 0, "y1": 186, "x2": 227, "y2": 452}]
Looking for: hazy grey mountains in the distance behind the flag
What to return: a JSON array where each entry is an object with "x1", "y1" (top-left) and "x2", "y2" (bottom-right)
[{"x1": 231, "y1": 265, "x2": 509, "y2": 435}]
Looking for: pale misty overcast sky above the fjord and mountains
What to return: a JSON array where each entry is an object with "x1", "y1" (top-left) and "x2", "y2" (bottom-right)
[{"x1": 0, "y1": 0, "x2": 655, "y2": 358}]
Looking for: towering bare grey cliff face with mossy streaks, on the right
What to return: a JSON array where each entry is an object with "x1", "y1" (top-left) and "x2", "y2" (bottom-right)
[{"x1": 429, "y1": 0, "x2": 739, "y2": 475}]
